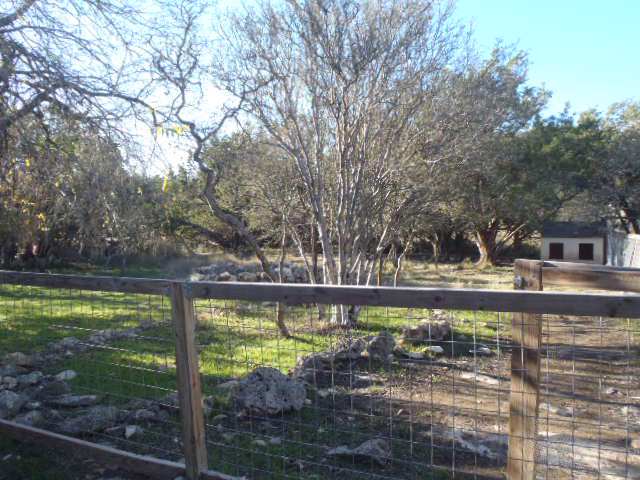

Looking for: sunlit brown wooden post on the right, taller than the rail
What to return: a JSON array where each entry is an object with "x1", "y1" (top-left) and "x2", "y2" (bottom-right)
[{"x1": 507, "y1": 260, "x2": 543, "y2": 480}]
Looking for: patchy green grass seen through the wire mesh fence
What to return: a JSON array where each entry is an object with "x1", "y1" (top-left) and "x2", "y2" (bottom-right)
[{"x1": 0, "y1": 270, "x2": 508, "y2": 479}]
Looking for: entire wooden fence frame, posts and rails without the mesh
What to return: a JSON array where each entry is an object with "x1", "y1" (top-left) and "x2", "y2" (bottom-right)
[{"x1": 0, "y1": 261, "x2": 640, "y2": 480}]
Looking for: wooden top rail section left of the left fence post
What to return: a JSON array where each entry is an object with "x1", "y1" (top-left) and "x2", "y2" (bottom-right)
[{"x1": 0, "y1": 270, "x2": 171, "y2": 295}]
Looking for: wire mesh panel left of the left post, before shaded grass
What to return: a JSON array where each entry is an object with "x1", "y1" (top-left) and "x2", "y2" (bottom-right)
[{"x1": 0, "y1": 285, "x2": 182, "y2": 460}]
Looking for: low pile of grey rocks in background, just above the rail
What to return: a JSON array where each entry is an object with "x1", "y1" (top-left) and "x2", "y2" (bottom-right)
[{"x1": 190, "y1": 261, "x2": 309, "y2": 283}]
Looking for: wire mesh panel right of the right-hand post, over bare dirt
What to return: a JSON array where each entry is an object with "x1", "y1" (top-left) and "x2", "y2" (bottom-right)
[{"x1": 537, "y1": 315, "x2": 640, "y2": 479}]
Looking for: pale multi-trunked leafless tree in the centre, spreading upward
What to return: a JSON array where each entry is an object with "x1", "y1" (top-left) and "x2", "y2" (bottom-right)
[{"x1": 220, "y1": 0, "x2": 460, "y2": 325}]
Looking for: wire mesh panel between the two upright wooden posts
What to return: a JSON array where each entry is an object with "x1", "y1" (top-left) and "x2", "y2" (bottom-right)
[{"x1": 196, "y1": 300, "x2": 510, "y2": 479}]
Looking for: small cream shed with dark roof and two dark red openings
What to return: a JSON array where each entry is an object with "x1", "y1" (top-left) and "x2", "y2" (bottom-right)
[{"x1": 542, "y1": 222, "x2": 607, "y2": 265}]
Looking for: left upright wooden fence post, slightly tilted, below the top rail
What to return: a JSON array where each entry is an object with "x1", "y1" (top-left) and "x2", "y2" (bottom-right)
[{"x1": 171, "y1": 282, "x2": 208, "y2": 480}]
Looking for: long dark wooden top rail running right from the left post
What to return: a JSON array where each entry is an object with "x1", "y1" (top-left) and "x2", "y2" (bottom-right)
[{"x1": 188, "y1": 282, "x2": 640, "y2": 318}]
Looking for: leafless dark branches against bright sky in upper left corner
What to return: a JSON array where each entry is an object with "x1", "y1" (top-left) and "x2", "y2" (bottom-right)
[{"x1": 0, "y1": 0, "x2": 159, "y2": 176}]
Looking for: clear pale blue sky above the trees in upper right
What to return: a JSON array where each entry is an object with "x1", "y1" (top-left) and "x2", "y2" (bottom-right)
[{"x1": 457, "y1": 0, "x2": 640, "y2": 113}]
